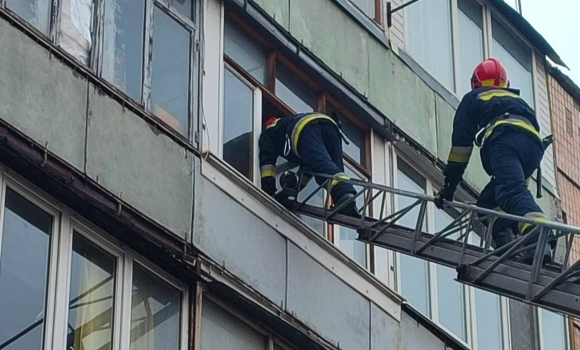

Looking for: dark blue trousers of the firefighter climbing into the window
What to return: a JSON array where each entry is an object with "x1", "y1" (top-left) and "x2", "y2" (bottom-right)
[{"x1": 298, "y1": 121, "x2": 356, "y2": 202}]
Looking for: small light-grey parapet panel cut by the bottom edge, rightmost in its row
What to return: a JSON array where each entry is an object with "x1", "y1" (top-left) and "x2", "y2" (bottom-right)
[{"x1": 402, "y1": 312, "x2": 446, "y2": 350}]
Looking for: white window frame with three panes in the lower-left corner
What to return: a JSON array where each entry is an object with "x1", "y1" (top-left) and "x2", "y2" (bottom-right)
[{"x1": 0, "y1": 164, "x2": 190, "y2": 350}]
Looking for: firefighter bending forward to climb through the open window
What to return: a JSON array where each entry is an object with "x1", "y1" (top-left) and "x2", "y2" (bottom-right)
[{"x1": 259, "y1": 113, "x2": 358, "y2": 216}]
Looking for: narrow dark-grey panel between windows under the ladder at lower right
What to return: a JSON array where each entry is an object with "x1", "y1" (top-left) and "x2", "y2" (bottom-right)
[{"x1": 509, "y1": 300, "x2": 534, "y2": 350}]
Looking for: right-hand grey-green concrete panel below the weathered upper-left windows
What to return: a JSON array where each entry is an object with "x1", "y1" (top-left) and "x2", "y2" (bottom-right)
[{"x1": 87, "y1": 87, "x2": 194, "y2": 238}]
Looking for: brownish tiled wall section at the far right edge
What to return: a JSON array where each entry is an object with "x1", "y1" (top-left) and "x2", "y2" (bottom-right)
[{"x1": 548, "y1": 68, "x2": 580, "y2": 349}]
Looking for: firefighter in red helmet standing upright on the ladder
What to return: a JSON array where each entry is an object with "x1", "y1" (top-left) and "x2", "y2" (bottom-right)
[{"x1": 435, "y1": 58, "x2": 551, "y2": 263}]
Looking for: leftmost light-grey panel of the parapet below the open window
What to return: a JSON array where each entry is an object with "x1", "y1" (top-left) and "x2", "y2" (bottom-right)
[{"x1": 193, "y1": 177, "x2": 286, "y2": 306}]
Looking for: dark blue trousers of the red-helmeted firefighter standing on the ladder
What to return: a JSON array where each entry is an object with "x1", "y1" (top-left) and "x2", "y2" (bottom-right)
[{"x1": 477, "y1": 128, "x2": 544, "y2": 245}]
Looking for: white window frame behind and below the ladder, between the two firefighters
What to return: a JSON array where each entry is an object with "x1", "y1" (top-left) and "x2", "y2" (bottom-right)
[{"x1": 392, "y1": 152, "x2": 512, "y2": 350}]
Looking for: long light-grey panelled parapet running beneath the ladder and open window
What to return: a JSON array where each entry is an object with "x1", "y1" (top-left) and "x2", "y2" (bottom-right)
[{"x1": 193, "y1": 173, "x2": 458, "y2": 350}]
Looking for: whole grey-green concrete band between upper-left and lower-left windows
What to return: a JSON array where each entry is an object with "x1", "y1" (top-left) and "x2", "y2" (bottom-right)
[{"x1": 0, "y1": 20, "x2": 193, "y2": 238}]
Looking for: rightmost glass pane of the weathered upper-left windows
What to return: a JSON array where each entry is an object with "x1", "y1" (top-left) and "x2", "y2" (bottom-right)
[{"x1": 151, "y1": 7, "x2": 191, "y2": 134}]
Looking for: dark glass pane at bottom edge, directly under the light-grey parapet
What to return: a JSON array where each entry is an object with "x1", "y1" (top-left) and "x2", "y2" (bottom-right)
[{"x1": 201, "y1": 298, "x2": 268, "y2": 350}]
